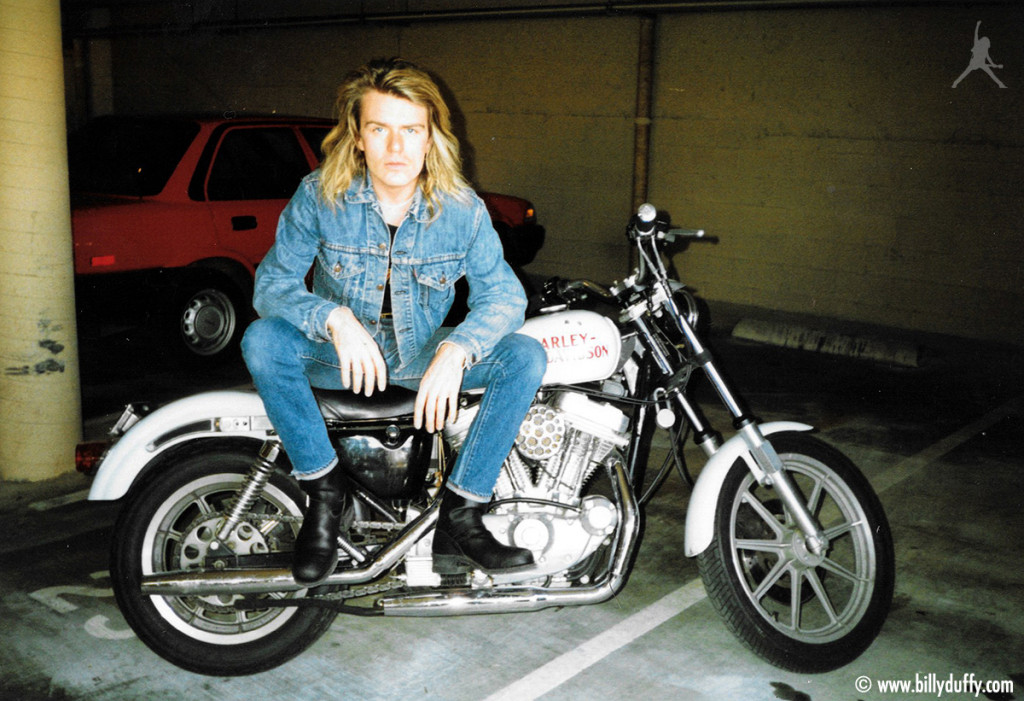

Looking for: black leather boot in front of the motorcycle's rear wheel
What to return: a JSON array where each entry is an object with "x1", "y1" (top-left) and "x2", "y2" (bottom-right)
[{"x1": 292, "y1": 467, "x2": 345, "y2": 584}]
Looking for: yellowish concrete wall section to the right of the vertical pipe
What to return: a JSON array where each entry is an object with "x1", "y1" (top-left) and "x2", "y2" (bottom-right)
[{"x1": 651, "y1": 7, "x2": 1024, "y2": 343}]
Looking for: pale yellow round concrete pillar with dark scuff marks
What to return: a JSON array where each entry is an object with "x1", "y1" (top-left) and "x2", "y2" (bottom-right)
[{"x1": 0, "y1": 0, "x2": 82, "y2": 481}]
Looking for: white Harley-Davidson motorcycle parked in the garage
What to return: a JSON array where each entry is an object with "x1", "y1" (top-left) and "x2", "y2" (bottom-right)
[{"x1": 83, "y1": 205, "x2": 894, "y2": 675}]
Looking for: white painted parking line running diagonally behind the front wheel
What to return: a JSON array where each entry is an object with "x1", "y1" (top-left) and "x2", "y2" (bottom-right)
[{"x1": 486, "y1": 396, "x2": 1024, "y2": 701}]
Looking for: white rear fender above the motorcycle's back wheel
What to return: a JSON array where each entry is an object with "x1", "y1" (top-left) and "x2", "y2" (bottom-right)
[{"x1": 89, "y1": 390, "x2": 273, "y2": 500}]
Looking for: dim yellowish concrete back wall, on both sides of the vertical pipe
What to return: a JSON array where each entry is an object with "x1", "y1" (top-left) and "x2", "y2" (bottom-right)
[{"x1": 75, "y1": 4, "x2": 1024, "y2": 343}]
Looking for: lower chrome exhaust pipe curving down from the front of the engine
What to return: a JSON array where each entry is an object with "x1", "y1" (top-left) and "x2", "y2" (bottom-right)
[{"x1": 380, "y1": 461, "x2": 640, "y2": 617}]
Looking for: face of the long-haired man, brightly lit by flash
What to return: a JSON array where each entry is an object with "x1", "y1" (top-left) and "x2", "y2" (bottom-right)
[{"x1": 356, "y1": 90, "x2": 430, "y2": 202}]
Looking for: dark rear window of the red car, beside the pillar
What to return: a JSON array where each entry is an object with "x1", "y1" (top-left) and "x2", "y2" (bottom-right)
[{"x1": 68, "y1": 119, "x2": 199, "y2": 196}]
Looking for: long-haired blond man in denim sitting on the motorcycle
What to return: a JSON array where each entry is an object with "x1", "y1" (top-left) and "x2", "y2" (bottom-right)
[{"x1": 243, "y1": 58, "x2": 547, "y2": 584}]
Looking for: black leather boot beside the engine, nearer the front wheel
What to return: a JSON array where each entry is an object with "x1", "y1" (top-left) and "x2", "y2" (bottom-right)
[{"x1": 433, "y1": 490, "x2": 534, "y2": 574}]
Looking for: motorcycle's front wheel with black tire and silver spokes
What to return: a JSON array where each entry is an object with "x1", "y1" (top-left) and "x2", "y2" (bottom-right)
[{"x1": 697, "y1": 433, "x2": 895, "y2": 673}]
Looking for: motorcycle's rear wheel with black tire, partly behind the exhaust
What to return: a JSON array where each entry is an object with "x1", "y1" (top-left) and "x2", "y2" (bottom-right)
[{"x1": 111, "y1": 447, "x2": 336, "y2": 675}]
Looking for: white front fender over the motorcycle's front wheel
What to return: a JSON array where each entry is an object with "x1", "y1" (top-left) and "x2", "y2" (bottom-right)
[{"x1": 684, "y1": 421, "x2": 813, "y2": 558}]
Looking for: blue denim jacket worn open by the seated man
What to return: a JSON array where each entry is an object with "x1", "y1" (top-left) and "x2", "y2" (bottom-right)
[{"x1": 253, "y1": 171, "x2": 526, "y2": 366}]
